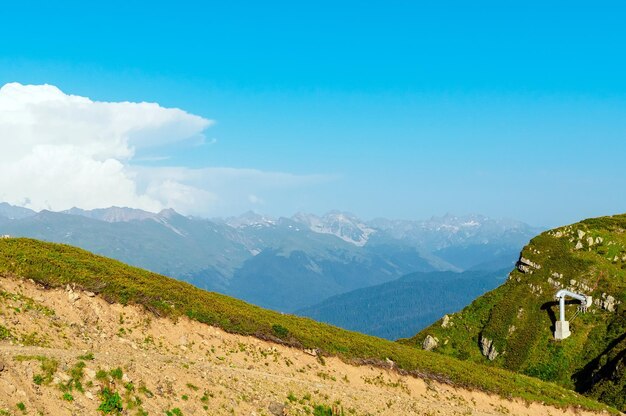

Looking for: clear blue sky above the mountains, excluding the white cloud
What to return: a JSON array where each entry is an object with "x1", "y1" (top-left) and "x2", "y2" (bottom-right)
[{"x1": 0, "y1": 1, "x2": 626, "y2": 226}]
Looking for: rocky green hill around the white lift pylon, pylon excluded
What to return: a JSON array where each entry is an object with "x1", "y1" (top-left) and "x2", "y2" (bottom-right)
[{"x1": 402, "y1": 215, "x2": 626, "y2": 411}]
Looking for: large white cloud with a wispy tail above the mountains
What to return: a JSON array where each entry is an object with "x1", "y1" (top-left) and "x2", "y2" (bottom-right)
[{"x1": 0, "y1": 83, "x2": 324, "y2": 215}]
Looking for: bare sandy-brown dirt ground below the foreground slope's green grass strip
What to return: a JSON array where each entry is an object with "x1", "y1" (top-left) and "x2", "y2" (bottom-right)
[{"x1": 0, "y1": 278, "x2": 608, "y2": 416}]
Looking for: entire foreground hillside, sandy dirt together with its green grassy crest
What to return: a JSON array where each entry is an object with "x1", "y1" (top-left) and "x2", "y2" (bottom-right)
[{"x1": 0, "y1": 238, "x2": 612, "y2": 416}]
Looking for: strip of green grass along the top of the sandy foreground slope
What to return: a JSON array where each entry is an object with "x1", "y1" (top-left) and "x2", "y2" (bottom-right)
[{"x1": 0, "y1": 239, "x2": 616, "y2": 409}]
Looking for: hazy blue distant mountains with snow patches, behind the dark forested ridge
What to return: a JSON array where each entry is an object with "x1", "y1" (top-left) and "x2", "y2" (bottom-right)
[{"x1": 0, "y1": 203, "x2": 537, "y2": 312}]
